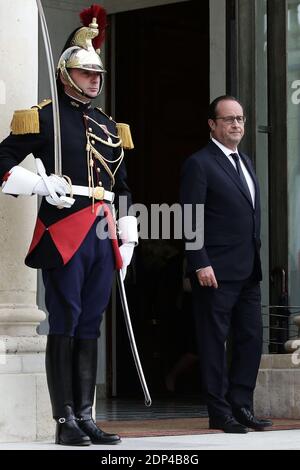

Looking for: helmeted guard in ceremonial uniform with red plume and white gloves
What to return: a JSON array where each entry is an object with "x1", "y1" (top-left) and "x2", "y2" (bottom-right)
[{"x1": 0, "y1": 5, "x2": 137, "y2": 445}]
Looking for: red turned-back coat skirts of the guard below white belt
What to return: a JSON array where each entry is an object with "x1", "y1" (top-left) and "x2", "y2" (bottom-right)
[{"x1": 28, "y1": 201, "x2": 123, "y2": 269}]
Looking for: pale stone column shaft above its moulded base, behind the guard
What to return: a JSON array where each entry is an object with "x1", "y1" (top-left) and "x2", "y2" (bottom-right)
[{"x1": 0, "y1": 0, "x2": 38, "y2": 322}]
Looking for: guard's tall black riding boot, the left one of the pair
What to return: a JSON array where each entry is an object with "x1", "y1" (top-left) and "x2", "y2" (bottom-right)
[{"x1": 46, "y1": 335, "x2": 91, "y2": 446}]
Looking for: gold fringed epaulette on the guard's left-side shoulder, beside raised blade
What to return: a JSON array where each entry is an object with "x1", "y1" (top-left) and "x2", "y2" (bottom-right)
[{"x1": 10, "y1": 100, "x2": 51, "y2": 135}]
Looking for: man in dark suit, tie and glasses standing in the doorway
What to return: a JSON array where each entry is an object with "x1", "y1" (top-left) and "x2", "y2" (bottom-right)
[{"x1": 181, "y1": 95, "x2": 272, "y2": 433}]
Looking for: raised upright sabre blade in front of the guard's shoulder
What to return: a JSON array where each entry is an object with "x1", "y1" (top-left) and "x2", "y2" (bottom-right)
[{"x1": 36, "y1": 0, "x2": 62, "y2": 176}]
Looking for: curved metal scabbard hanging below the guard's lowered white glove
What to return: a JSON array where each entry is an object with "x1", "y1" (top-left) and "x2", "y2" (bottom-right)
[{"x1": 117, "y1": 271, "x2": 152, "y2": 406}]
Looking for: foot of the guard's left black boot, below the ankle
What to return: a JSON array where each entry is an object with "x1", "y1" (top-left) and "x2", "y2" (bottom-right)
[{"x1": 55, "y1": 418, "x2": 91, "y2": 446}]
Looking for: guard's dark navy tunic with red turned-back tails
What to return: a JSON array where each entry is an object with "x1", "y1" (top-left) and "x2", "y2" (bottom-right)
[{"x1": 0, "y1": 93, "x2": 131, "y2": 269}]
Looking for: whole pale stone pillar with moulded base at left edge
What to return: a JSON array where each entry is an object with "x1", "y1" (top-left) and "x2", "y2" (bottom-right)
[{"x1": 0, "y1": 0, "x2": 53, "y2": 442}]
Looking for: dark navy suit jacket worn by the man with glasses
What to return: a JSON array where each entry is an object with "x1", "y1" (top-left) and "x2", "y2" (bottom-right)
[{"x1": 181, "y1": 141, "x2": 261, "y2": 281}]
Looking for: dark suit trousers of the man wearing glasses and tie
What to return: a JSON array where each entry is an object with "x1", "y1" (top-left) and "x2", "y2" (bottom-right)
[{"x1": 192, "y1": 276, "x2": 262, "y2": 417}]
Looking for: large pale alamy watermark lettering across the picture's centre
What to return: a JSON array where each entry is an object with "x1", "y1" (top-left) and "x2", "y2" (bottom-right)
[{"x1": 96, "y1": 196, "x2": 204, "y2": 251}]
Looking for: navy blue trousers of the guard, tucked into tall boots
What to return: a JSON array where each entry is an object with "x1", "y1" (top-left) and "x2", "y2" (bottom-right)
[{"x1": 43, "y1": 222, "x2": 115, "y2": 339}]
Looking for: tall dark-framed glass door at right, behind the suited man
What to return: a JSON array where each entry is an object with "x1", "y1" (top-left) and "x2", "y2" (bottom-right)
[{"x1": 232, "y1": 0, "x2": 300, "y2": 353}]
